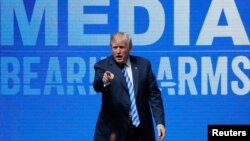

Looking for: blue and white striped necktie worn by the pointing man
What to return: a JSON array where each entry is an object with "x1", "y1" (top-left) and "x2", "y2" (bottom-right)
[{"x1": 122, "y1": 65, "x2": 140, "y2": 127}]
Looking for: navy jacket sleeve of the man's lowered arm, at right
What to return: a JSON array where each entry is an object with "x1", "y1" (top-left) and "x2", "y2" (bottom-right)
[{"x1": 147, "y1": 62, "x2": 165, "y2": 126}]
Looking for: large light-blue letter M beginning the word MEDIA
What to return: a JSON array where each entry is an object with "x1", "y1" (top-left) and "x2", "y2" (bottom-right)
[{"x1": 0, "y1": 0, "x2": 58, "y2": 45}]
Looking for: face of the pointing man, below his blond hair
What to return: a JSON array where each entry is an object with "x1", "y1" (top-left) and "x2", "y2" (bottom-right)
[{"x1": 111, "y1": 41, "x2": 130, "y2": 63}]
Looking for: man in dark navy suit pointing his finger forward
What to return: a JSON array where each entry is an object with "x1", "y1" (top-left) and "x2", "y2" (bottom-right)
[{"x1": 93, "y1": 32, "x2": 166, "y2": 141}]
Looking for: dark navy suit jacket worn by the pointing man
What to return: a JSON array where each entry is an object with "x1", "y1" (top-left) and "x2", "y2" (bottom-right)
[{"x1": 93, "y1": 56, "x2": 165, "y2": 141}]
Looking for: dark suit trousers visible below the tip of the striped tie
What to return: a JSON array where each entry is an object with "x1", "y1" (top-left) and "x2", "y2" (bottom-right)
[{"x1": 125, "y1": 117, "x2": 142, "y2": 141}]
